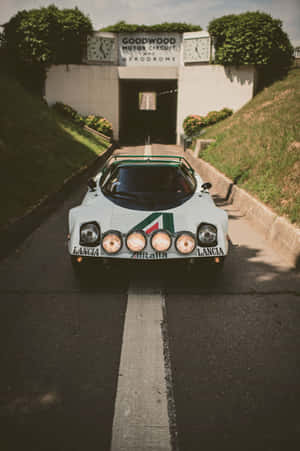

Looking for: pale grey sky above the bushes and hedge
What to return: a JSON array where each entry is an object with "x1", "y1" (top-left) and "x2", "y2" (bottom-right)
[{"x1": 0, "y1": 0, "x2": 300, "y2": 46}]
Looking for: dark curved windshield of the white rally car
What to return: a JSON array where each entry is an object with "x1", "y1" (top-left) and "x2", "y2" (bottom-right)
[{"x1": 103, "y1": 165, "x2": 195, "y2": 196}]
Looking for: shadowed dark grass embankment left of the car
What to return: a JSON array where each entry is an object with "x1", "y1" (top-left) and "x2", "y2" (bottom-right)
[{"x1": 0, "y1": 74, "x2": 108, "y2": 227}]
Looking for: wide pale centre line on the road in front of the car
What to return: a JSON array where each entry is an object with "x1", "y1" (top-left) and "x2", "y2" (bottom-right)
[{"x1": 111, "y1": 287, "x2": 172, "y2": 451}]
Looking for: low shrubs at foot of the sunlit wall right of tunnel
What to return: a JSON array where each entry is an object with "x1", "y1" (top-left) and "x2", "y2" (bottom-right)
[{"x1": 183, "y1": 108, "x2": 233, "y2": 136}]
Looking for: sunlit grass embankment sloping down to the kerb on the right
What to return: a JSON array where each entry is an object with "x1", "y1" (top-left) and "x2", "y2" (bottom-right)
[{"x1": 201, "y1": 68, "x2": 300, "y2": 226}]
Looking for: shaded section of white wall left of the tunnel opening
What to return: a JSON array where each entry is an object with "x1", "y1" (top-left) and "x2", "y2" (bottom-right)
[{"x1": 45, "y1": 64, "x2": 119, "y2": 140}]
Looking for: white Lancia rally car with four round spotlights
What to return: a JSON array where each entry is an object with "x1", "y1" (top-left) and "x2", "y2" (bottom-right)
[{"x1": 68, "y1": 155, "x2": 228, "y2": 276}]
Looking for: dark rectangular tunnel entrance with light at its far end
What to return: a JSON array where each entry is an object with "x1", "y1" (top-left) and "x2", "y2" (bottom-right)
[{"x1": 120, "y1": 80, "x2": 177, "y2": 145}]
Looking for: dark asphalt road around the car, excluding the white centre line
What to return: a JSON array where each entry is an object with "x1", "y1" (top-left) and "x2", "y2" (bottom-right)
[{"x1": 0, "y1": 145, "x2": 300, "y2": 451}]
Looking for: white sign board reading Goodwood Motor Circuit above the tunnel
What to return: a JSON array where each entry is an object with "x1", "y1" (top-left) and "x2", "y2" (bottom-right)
[{"x1": 119, "y1": 33, "x2": 182, "y2": 66}]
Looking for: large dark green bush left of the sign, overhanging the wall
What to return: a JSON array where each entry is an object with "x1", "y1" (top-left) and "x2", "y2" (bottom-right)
[{"x1": 0, "y1": 5, "x2": 93, "y2": 97}]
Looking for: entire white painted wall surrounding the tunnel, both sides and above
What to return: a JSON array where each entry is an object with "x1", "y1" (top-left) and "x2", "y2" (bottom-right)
[{"x1": 45, "y1": 64, "x2": 255, "y2": 143}]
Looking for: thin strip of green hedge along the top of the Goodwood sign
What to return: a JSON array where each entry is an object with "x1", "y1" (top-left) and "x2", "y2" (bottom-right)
[{"x1": 100, "y1": 20, "x2": 202, "y2": 33}]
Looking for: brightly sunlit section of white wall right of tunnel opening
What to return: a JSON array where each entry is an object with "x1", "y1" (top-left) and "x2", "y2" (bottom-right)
[{"x1": 177, "y1": 64, "x2": 255, "y2": 144}]
